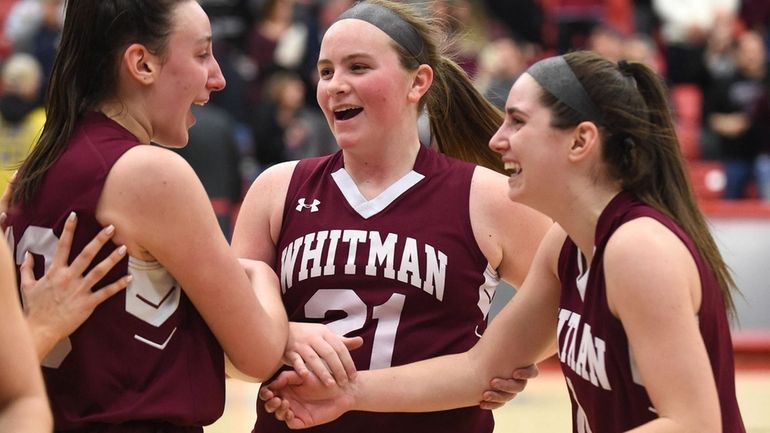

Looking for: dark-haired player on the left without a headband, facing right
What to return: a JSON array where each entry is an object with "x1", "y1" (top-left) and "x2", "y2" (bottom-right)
[{"x1": 6, "y1": 0, "x2": 288, "y2": 432}]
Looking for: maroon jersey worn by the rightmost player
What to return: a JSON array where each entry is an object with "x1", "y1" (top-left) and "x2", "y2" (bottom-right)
[{"x1": 558, "y1": 192, "x2": 745, "y2": 433}]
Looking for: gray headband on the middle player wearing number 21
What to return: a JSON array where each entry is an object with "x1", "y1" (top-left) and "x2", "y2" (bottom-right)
[{"x1": 334, "y1": 2, "x2": 424, "y2": 60}]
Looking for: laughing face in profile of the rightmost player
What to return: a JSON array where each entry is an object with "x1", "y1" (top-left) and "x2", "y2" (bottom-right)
[{"x1": 489, "y1": 74, "x2": 570, "y2": 208}]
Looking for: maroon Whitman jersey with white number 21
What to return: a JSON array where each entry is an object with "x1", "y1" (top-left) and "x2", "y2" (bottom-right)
[{"x1": 255, "y1": 147, "x2": 497, "y2": 433}]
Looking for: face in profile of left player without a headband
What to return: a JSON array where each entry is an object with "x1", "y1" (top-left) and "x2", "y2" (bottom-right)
[{"x1": 148, "y1": 1, "x2": 225, "y2": 147}]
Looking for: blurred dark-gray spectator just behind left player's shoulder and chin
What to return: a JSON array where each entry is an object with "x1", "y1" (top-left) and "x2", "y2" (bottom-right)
[{"x1": 172, "y1": 104, "x2": 242, "y2": 241}]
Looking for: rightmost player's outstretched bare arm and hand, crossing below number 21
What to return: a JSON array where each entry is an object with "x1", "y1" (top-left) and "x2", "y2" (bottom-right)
[{"x1": 260, "y1": 227, "x2": 564, "y2": 428}]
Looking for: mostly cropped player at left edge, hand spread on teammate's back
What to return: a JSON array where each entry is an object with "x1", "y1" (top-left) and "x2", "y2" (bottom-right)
[{"x1": 0, "y1": 197, "x2": 130, "y2": 432}]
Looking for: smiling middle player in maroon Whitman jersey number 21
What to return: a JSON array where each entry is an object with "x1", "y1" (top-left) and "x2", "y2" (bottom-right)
[{"x1": 233, "y1": 2, "x2": 551, "y2": 433}]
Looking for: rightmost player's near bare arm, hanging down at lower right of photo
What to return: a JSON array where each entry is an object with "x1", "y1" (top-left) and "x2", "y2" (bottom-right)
[{"x1": 604, "y1": 218, "x2": 722, "y2": 433}]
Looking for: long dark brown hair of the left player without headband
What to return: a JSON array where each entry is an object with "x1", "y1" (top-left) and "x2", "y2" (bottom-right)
[{"x1": 13, "y1": 0, "x2": 192, "y2": 203}]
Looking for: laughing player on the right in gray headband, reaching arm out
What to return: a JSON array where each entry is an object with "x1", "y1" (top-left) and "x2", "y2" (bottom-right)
[{"x1": 261, "y1": 52, "x2": 745, "y2": 433}]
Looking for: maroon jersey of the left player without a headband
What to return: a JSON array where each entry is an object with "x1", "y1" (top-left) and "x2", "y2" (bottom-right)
[{"x1": 6, "y1": 113, "x2": 224, "y2": 432}]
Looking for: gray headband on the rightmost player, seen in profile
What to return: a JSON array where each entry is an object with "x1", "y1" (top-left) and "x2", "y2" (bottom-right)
[{"x1": 527, "y1": 56, "x2": 605, "y2": 125}]
